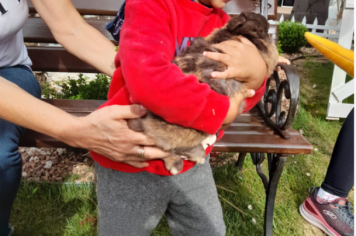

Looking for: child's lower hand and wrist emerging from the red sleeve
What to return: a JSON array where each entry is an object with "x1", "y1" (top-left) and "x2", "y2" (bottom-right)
[{"x1": 221, "y1": 89, "x2": 255, "y2": 129}]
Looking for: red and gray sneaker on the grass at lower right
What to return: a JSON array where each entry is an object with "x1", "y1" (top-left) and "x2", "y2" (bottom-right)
[{"x1": 299, "y1": 188, "x2": 354, "y2": 236}]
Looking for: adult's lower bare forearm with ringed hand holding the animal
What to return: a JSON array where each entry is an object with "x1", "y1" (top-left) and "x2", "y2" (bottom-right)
[{"x1": 0, "y1": 77, "x2": 168, "y2": 168}]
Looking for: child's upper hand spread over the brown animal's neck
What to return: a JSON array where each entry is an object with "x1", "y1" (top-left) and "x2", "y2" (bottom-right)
[{"x1": 204, "y1": 36, "x2": 267, "y2": 90}]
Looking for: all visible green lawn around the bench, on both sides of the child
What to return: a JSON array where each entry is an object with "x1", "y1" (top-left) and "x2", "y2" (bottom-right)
[{"x1": 11, "y1": 60, "x2": 354, "y2": 236}]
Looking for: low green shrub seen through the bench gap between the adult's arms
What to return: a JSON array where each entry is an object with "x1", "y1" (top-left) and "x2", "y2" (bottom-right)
[{"x1": 42, "y1": 74, "x2": 110, "y2": 100}]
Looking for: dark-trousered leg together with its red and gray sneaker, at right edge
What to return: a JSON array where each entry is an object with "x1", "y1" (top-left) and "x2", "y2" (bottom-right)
[{"x1": 299, "y1": 110, "x2": 354, "y2": 236}]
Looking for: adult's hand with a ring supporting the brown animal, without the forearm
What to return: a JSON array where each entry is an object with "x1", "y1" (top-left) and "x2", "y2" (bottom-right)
[{"x1": 61, "y1": 105, "x2": 169, "y2": 168}]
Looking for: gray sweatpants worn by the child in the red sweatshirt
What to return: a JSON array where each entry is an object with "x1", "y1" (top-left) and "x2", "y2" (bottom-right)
[{"x1": 95, "y1": 157, "x2": 225, "y2": 236}]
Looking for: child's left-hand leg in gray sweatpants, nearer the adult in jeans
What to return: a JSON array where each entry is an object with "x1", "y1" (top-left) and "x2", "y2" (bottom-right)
[{"x1": 95, "y1": 164, "x2": 170, "y2": 236}]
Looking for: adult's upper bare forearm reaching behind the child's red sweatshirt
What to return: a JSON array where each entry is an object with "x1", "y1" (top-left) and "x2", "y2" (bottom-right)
[{"x1": 31, "y1": 0, "x2": 116, "y2": 77}]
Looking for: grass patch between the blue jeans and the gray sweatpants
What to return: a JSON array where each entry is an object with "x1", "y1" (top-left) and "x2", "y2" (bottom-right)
[{"x1": 11, "y1": 182, "x2": 97, "y2": 236}]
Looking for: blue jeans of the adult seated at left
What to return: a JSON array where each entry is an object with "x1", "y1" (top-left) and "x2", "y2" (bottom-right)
[{"x1": 0, "y1": 66, "x2": 41, "y2": 236}]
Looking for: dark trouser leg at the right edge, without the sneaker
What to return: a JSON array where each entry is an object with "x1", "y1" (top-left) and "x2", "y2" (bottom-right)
[{"x1": 321, "y1": 109, "x2": 355, "y2": 200}]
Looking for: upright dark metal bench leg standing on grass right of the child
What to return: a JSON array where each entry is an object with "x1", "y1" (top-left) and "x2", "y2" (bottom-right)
[{"x1": 264, "y1": 154, "x2": 287, "y2": 236}]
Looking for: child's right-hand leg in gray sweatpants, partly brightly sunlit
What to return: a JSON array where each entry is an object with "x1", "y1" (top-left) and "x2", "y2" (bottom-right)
[{"x1": 166, "y1": 157, "x2": 226, "y2": 236}]
